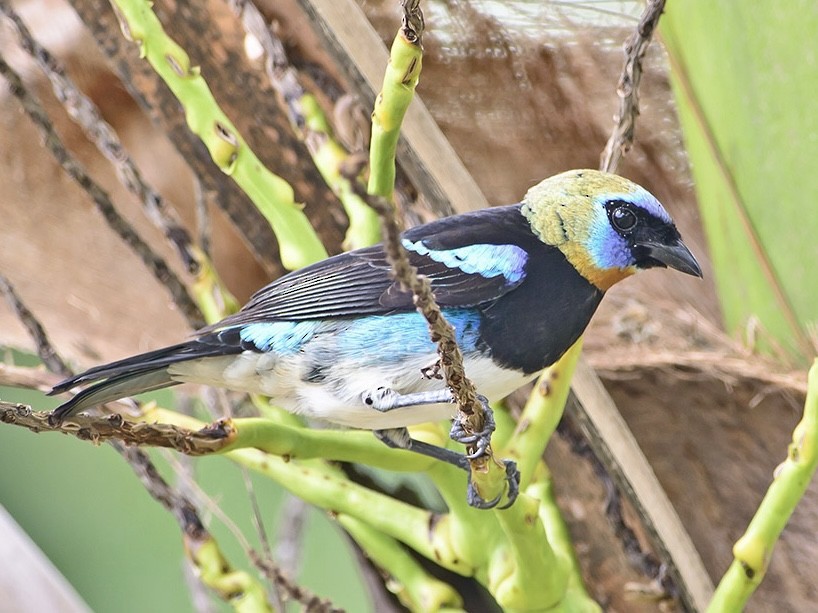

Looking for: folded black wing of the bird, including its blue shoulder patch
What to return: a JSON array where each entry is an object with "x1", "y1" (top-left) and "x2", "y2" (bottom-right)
[{"x1": 205, "y1": 205, "x2": 545, "y2": 331}]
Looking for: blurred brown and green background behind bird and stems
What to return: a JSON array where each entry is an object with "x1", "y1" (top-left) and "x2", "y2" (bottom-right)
[{"x1": 0, "y1": 0, "x2": 818, "y2": 611}]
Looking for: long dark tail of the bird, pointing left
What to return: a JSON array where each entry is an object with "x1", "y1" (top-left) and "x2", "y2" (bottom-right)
[{"x1": 49, "y1": 331, "x2": 242, "y2": 424}]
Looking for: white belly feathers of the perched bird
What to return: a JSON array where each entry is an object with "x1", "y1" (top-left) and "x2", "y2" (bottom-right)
[{"x1": 169, "y1": 351, "x2": 537, "y2": 430}]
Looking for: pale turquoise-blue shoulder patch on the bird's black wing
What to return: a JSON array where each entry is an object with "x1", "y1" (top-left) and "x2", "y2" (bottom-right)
[{"x1": 401, "y1": 238, "x2": 528, "y2": 283}]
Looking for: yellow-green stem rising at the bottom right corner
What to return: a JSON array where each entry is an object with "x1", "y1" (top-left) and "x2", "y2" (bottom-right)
[{"x1": 707, "y1": 359, "x2": 818, "y2": 613}]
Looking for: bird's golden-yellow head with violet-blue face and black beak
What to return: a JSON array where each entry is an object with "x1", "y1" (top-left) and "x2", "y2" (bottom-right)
[{"x1": 522, "y1": 170, "x2": 702, "y2": 291}]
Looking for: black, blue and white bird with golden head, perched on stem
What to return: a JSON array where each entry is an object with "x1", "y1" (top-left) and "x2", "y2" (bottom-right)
[{"x1": 52, "y1": 170, "x2": 701, "y2": 506}]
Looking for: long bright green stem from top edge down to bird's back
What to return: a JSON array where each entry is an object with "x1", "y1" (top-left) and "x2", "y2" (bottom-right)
[{"x1": 111, "y1": 0, "x2": 327, "y2": 269}]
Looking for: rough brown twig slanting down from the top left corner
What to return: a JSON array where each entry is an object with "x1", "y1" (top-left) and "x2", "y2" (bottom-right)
[{"x1": 0, "y1": 2, "x2": 199, "y2": 274}]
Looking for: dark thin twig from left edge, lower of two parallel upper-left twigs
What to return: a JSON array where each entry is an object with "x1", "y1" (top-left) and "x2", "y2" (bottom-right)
[{"x1": 0, "y1": 57, "x2": 205, "y2": 328}]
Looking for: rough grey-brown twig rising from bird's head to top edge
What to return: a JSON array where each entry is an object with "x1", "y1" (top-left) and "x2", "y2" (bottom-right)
[{"x1": 599, "y1": 0, "x2": 665, "y2": 172}]
